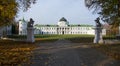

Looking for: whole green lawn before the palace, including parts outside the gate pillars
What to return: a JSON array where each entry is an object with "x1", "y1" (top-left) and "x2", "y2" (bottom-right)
[{"x1": 8, "y1": 34, "x2": 115, "y2": 43}]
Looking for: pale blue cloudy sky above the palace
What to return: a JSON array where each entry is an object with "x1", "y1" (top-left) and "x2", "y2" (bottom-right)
[{"x1": 17, "y1": 0, "x2": 98, "y2": 25}]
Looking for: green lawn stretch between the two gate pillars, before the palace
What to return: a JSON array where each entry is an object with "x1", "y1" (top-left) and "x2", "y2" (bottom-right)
[{"x1": 35, "y1": 35, "x2": 94, "y2": 43}]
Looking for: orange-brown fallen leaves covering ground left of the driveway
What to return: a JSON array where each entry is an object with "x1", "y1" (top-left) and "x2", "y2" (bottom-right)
[{"x1": 0, "y1": 40, "x2": 35, "y2": 66}]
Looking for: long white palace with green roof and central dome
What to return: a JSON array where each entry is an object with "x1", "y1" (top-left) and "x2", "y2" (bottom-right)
[{"x1": 19, "y1": 17, "x2": 106, "y2": 35}]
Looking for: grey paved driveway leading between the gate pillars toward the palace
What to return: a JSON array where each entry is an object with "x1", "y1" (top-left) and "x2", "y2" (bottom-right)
[{"x1": 24, "y1": 39, "x2": 120, "y2": 66}]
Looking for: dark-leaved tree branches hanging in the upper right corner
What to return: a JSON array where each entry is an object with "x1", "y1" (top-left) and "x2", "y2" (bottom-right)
[{"x1": 85, "y1": 0, "x2": 120, "y2": 27}]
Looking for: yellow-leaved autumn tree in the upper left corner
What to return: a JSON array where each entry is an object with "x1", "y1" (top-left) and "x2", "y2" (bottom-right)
[{"x1": 0, "y1": 0, "x2": 36, "y2": 26}]
